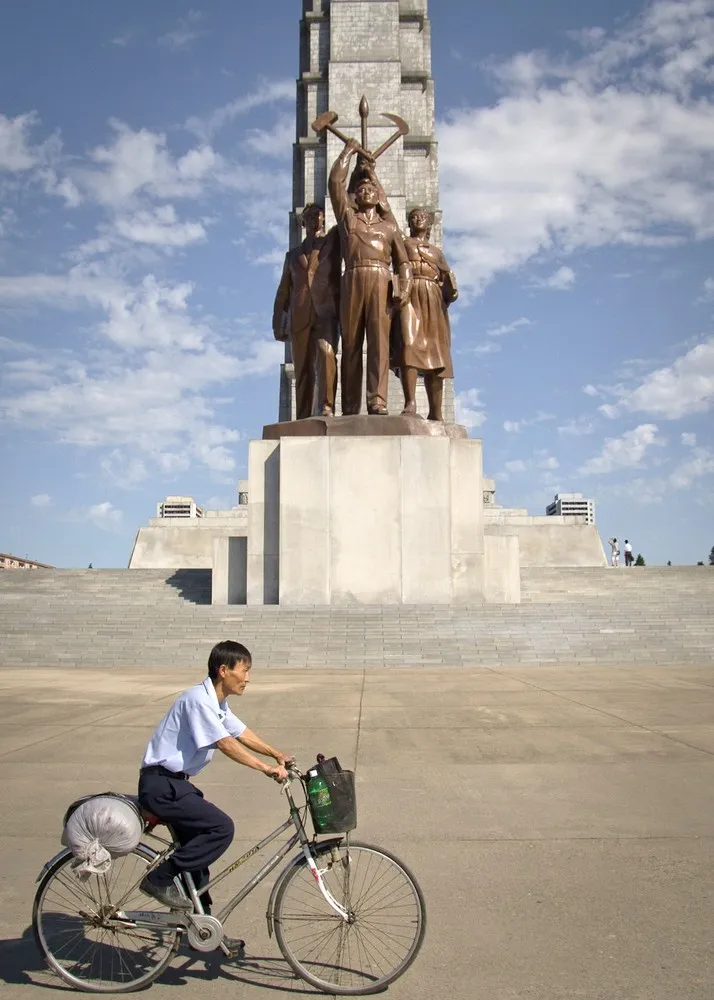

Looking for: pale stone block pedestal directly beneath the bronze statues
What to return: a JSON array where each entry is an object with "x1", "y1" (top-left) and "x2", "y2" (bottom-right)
[{"x1": 247, "y1": 434, "x2": 496, "y2": 606}]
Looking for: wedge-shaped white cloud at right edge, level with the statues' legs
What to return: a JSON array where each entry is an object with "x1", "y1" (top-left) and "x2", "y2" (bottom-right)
[{"x1": 600, "y1": 337, "x2": 714, "y2": 420}]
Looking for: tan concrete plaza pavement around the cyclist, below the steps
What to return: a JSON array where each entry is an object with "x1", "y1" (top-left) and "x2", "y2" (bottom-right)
[{"x1": 0, "y1": 665, "x2": 714, "y2": 1000}]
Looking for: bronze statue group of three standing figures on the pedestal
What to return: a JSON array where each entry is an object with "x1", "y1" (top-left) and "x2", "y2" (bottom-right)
[{"x1": 273, "y1": 134, "x2": 458, "y2": 421}]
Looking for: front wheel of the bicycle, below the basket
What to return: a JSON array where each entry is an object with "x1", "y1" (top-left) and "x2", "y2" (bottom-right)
[{"x1": 273, "y1": 842, "x2": 426, "y2": 996}]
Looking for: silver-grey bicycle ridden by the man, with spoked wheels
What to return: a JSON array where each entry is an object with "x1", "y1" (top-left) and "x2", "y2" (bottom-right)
[{"x1": 32, "y1": 766, "x2": 426, "y2": 996}]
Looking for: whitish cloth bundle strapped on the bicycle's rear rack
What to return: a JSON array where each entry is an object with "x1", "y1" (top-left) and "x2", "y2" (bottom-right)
[{"x1": 62, "y1": 795, "x2": 144, "y2": 876}]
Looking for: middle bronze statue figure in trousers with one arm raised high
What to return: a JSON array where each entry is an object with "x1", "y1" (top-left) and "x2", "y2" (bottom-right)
[{"x1": 329, "y1": 140, "x2": 411, "y2": 415}]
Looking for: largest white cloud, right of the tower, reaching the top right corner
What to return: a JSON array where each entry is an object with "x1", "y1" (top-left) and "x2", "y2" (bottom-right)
[{"x1": 439, "y1": 0, "x2": 714, "y2": 289}]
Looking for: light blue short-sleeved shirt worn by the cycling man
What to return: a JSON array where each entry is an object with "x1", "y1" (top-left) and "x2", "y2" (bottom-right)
[{"x1": 141, "y1": 677, "x2": 247, "y2": 775}]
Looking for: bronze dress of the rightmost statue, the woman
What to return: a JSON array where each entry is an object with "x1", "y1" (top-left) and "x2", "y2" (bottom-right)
[{"x1": 391, "y1": 236, "x2": 456, "y2": 378}]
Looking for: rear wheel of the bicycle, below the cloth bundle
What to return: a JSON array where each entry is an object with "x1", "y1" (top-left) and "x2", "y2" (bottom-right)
[{"x1": 32, "y1": 844, "x2": 179, "y2": 993}]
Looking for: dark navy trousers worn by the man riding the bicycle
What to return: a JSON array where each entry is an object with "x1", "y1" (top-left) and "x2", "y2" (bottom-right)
[{"x1": 139, "y1": 771, "x2": 234, "y2": 908}]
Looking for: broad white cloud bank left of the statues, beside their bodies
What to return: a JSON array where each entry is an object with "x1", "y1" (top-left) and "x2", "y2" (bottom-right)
[{"x1": 0, "y1": 269, "x2": 283, "y2": 485}]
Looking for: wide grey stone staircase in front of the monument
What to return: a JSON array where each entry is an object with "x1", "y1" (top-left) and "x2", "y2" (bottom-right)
[{"x1": 0, "y1": 566, "x2": 714, "y2": 669}]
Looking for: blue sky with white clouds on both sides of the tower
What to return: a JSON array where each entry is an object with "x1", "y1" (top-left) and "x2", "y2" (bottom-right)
[{"x1": 0, "y1": 0, "x2": 714, "y2": 566}]
